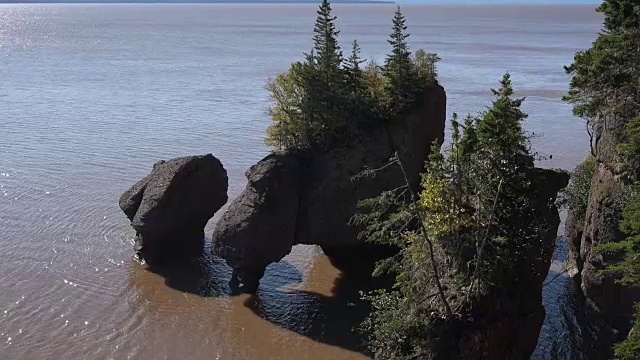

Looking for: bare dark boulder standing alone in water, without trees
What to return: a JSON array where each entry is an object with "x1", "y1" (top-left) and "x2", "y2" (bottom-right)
[{"x1": 119, "y1": 154, "x2": 228, "y2": 264}]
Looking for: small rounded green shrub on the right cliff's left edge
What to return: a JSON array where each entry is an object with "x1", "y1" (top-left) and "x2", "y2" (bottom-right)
[{"x1": 562, "y1": 156, "x2": 596, "y2": 224}]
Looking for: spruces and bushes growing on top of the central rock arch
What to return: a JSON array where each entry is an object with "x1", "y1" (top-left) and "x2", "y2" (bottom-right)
[{"x1": 266, "y1": 0, "x2": 439, "y2": 149}]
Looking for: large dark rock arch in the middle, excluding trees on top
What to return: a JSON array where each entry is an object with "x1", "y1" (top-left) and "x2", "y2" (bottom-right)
[{"x1": 212, "y1": 85, "x2": 446, "y2": 291}]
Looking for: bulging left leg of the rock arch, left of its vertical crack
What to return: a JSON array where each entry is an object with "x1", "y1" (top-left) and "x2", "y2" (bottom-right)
[{"x1": 213, "y1": 152, "x2": 301, "y2": 292}]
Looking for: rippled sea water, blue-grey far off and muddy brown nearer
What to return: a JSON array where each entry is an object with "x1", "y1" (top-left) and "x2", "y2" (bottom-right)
[{"x1": 0, "y1": 5, "x2": 601, "y2": 360}]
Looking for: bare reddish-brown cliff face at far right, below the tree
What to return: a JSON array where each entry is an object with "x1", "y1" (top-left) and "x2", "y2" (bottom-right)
[{"x1": 566, "y1": 127, "x2": 640, "y2": 359}]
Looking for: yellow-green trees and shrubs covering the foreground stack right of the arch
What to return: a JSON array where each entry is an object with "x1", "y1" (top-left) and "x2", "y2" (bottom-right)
[{"x1": 355, "y1": 74, "x2": 553, "y2": 359}]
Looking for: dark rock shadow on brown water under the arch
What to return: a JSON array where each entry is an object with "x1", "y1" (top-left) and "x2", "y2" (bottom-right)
[{"x1": 244, "y1": 262, "x2": 384, "y2": 356}]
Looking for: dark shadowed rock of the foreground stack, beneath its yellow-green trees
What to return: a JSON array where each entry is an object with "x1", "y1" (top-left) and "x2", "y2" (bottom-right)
[{"x1": 435, "y1": 168, "x2": 569, "y2": 360}]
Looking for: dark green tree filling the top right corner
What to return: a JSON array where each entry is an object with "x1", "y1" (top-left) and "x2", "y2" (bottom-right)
[{"x1": 565, "y1": 0, "x2": 640, "y2": 166}]
